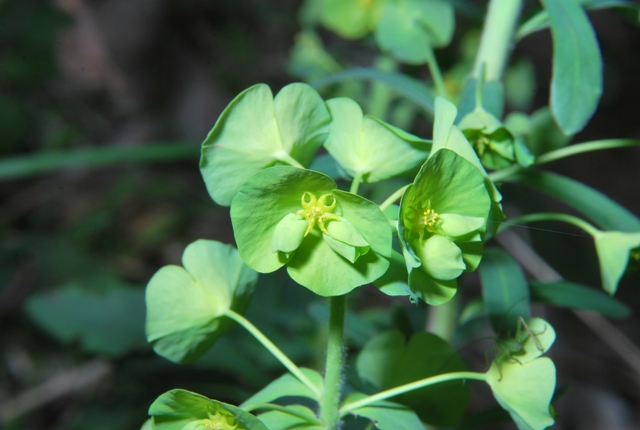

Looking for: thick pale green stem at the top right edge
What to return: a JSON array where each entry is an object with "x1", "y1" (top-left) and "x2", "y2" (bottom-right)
[{"x1": 473, "y1": 0, "x2": 522, "y2": 82}]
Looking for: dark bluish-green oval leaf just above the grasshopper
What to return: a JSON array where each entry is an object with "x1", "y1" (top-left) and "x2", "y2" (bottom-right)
[{"x1": 480, "y1": 248, "x2": 530, "y2": 335}]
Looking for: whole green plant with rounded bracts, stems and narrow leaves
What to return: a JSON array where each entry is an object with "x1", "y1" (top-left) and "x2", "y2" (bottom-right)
[{"x1": 145, "y1": 0, "x2": 640, "y2": 430}]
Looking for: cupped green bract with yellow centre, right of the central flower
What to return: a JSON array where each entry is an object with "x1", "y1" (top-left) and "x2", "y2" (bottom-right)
[{"x1": 398, "y1": 149, "x2": 491, "y2": 305}]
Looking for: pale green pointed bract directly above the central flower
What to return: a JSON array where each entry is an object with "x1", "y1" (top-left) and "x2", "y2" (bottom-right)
[{"x1": 324, "y1": 98, "x2": 431, "y2": 182}]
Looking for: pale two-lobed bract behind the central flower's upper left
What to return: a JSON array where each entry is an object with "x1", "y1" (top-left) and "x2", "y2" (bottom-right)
[{"x1": 200, "y1": 83, "x2": 331, "y2": 206}]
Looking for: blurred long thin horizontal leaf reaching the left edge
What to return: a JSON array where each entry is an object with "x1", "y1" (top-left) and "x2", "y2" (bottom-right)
[{"x1": 0, "y1": 143, "x2": 199, "y2": 180}]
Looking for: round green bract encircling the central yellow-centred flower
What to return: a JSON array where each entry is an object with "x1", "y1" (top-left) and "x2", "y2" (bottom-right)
[{"x1": 231, "y1": 166, "x2": 391, "y2": 296}]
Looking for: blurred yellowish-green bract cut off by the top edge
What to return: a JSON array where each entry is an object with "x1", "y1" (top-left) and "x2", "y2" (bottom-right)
[{"x1": 321, "y1": 0, "x2": 384, "y2": 39}]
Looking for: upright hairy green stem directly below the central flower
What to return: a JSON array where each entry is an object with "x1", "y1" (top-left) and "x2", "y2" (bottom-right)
[{"x1": 320, "y1": 295, "x2": 346, "y2": 430}]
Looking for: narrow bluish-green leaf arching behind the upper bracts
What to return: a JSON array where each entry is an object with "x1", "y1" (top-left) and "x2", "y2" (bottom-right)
[{"x1": 310, "y1": 67, "x2": 435, "y2": 115}]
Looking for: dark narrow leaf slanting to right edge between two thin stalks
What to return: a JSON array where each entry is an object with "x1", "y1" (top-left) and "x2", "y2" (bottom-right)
[{"x1": 507, "y1": 169, "x2": 640, "y2": 232}]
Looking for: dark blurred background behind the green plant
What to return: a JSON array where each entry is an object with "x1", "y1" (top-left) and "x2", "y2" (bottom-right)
[{"x1": 0, "y1": 0, "x2": 640, "y2": 430}]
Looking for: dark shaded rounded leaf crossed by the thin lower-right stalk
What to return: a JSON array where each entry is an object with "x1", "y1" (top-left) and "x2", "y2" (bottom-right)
[{"x1": 357, "y1": 330, "x2": 469, "y2": 427}]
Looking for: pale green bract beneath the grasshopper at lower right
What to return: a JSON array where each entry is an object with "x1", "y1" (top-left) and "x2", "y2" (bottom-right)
[{"x1": 487, "y1": 357, "x2": 556, "y2": 430}]
